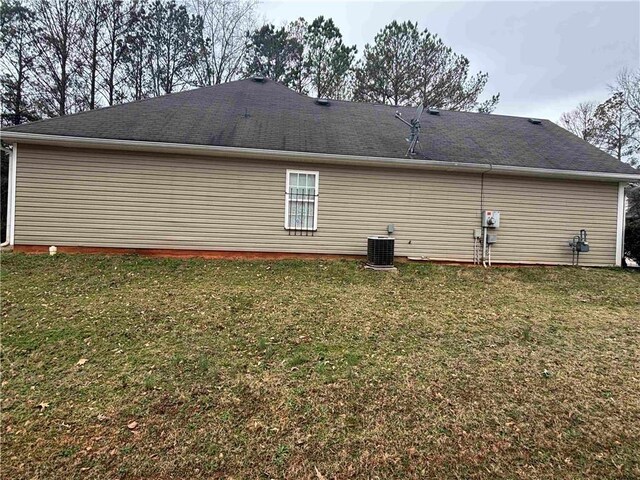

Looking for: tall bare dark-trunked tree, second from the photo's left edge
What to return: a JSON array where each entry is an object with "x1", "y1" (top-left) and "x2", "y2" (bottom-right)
[{"x1": 31, "y1": 0, "x2": 86, "y2": 116}]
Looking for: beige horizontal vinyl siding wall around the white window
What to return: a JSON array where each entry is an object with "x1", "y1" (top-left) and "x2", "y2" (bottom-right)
[{"x1": 15, "y1": 144, "x2": 618, "y2": 265}]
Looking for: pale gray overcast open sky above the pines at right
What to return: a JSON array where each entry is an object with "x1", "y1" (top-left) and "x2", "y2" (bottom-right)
[{"x1": 260, "y1": 0, "x2": 640, "y2": 121}]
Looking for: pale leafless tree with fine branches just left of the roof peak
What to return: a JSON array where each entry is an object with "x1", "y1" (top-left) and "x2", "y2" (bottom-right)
[{"x1": 191, "y1": 0, "x2": 258, "y2": 85}]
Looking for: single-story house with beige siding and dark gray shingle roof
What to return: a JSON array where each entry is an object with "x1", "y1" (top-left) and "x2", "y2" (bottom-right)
[{"x1": 2, "y1": 78, "x2": 640, "y2": 266}]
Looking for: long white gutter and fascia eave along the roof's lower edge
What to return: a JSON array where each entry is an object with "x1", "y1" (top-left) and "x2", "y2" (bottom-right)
[{"x1": 1, "y1": 131, "x2": 640, "y2": 182}]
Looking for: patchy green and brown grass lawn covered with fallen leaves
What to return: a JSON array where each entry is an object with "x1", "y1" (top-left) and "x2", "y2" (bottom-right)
[{"x1": 1, "y1": 254, "x2": 640, "y2": 480}]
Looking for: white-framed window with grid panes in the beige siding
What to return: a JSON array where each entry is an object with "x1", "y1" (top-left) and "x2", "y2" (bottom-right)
[{"x1": 284, "y1": 170, "x2": 319, "y2": 233}]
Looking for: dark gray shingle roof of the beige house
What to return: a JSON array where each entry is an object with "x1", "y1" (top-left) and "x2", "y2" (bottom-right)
[{"x1": 5, "y1": 80, "x2": 638, "y2": 173}]
